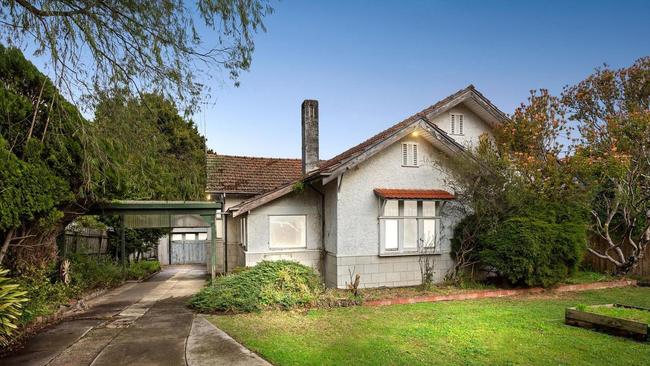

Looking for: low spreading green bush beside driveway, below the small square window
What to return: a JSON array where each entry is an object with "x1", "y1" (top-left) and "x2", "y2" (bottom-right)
[{"x1": 190, "y1": 260, "x2": 323, "y2": 312}]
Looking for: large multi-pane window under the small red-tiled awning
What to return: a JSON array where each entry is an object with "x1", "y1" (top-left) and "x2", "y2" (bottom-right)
[{"x1": 379, "y1": 200, "x2": 439, "y2": 254}]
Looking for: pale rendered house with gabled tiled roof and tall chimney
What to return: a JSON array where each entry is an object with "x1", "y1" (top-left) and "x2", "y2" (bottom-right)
[{"x1": 162, "y1": 85, "x2": 506, "y2": 288}]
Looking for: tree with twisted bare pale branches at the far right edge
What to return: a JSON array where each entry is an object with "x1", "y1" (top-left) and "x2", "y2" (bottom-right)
[{"x1": 563, "y1": 57, "x2": 650, "y2": 274}]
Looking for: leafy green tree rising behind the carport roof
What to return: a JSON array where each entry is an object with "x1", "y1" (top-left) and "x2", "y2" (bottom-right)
[{"x1": 89, "y1": 90, "x2": 206, "y2": 200}]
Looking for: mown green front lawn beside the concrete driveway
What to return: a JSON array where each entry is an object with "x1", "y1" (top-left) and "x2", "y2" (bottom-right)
[{"x1": 210, "y1": 288, "x2": 650, "y2": 365}]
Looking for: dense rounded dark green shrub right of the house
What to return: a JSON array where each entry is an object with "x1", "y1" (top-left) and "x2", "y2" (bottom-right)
[{"x1": 479, "y1": 216, "x2": 587, "y2": 287}]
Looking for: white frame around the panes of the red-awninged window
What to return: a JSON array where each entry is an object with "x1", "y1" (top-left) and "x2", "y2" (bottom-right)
[{"x1": 379, "y1": 199, "x2": 441, "y2": 256}]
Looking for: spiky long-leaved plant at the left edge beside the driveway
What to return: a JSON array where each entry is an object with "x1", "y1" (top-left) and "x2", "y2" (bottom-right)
[{"x1": 0, "y1": 269, "x2": 27, "y2": 346}]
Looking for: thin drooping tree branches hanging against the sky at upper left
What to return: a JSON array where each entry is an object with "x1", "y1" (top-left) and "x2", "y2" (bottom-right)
[{"x1": 0, "y1": 0, "x2": 272, "y2": 109}]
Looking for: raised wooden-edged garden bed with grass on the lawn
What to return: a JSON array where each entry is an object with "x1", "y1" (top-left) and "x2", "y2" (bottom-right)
[{"x1": 565, "y1": 304, "x2": 650, "y2": 341}]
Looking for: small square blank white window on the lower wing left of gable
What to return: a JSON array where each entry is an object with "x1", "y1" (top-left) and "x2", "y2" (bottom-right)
[{"x1": 269, "y1": 216, "x2": 307, "y2": 248}]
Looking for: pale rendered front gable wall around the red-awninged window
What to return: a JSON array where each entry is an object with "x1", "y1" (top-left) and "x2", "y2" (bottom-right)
[{"x1": 332, "y1": 134, "x2": 462, "y2": 288}]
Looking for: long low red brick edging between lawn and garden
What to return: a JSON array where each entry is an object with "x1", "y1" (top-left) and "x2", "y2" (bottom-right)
[{"x1": 363, "y1": 280, "x2": 637, "y2": 306}]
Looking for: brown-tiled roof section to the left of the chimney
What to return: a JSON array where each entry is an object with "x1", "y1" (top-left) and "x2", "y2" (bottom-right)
[{"x1": 206, "y1": 154, "x2": 302, "y2": 195}]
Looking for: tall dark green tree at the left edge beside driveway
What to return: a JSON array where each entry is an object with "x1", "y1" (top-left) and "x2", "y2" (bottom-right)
[{"x1": 0, "y1": 46, "x2": 87, "y2": 267}]
